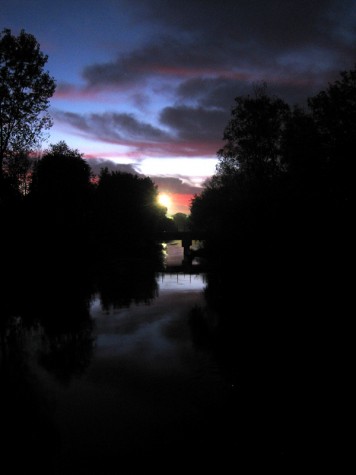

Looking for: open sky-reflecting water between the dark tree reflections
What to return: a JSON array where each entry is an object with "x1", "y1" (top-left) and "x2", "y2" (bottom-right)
[{"x1": 56, "y1": 275, "x2": 229, "y2": 473}]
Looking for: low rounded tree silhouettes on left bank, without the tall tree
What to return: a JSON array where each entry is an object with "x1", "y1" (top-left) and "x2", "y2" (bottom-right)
[{"x1": 0, "y1": 142, "x2": 171, "y2": 264}]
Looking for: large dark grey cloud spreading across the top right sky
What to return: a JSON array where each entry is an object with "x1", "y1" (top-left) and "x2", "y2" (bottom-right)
[{"x1": 84, "y1": 0, "x2": 355, "y2": 101}]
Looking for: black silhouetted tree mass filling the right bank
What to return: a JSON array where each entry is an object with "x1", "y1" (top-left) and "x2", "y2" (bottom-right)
[{"x1": 191, "y1": 66, "x2": 356, "y2": 464}]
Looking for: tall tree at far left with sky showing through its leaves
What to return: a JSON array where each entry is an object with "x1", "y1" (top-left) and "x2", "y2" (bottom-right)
[{"x1": 0, "y1": 29, "x2": 55, "y2": 176}]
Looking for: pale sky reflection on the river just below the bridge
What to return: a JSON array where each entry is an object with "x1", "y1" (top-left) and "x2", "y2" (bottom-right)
[{"x1": 91, "y1": 273, "x2": 205, "y2": 364}]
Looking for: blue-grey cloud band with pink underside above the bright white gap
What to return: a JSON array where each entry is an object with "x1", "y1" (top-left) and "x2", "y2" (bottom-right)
[{"x1": 52, "y1": 107, "x2": 227, "y2": 158}]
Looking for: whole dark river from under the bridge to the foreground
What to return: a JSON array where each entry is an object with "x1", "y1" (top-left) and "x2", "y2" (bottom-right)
[{"x1": 0, "y1": 242, "x2": 335, "y2": 475}]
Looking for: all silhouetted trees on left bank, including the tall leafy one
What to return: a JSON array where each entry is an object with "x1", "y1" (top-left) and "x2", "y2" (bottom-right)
[{"x1": 0, "y1": 28, "x2": 170, "y2": 288}]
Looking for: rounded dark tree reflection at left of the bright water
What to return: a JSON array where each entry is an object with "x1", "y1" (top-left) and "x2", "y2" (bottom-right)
[{"x1": 27, "y1": 261, "x2": 93, "y2": 382}]
